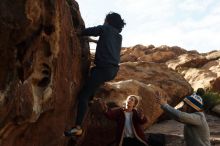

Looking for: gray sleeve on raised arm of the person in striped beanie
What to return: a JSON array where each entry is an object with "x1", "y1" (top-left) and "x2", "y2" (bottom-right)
[{"x1": 161, "y1": 104, "x2": 201, "y2": 125}]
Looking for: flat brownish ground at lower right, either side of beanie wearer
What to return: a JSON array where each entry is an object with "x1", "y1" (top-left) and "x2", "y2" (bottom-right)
[{"x1": 146, "y1": 115, "x2": 220, "y2": 146}]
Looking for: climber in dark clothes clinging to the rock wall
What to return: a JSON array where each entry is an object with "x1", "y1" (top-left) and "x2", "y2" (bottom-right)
[{"x1": 64, "y1": 12, "x2": 125, "y2": 136}]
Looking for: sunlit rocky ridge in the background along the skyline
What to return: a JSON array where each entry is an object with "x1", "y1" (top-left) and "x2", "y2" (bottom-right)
[{"x1": 121, "y1": 45, "x2": 220, "y2": 92}]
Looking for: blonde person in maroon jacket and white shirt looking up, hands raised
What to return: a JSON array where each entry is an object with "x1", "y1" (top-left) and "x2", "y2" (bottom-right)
[{"x1": 100, "y1": 95, "x2": 148, "y2": 146}]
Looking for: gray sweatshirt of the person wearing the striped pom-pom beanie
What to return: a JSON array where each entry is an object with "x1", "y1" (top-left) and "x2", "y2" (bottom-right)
[{"x1": 161, "y1": 104, "x2": 211, "y2": 146}]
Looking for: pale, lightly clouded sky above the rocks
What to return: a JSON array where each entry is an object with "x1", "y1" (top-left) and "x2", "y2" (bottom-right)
[{"x1": 76, "y1": 0, "x2": 220, "y2": 53}]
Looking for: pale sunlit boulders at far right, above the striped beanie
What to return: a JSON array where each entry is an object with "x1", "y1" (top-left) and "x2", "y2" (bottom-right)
[{"x1": 166, "y1": 52, "x2": 220, "y2": 92}]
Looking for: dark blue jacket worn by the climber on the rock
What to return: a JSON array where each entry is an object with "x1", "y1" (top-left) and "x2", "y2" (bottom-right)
[{"x1": 82, "y1": 24, "x2": 122, "y2": 67}]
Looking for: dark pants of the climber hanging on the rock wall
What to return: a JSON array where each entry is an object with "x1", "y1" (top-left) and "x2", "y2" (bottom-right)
[{"x1": 76, "y1": 66, "x2": 119, "y2": 126}]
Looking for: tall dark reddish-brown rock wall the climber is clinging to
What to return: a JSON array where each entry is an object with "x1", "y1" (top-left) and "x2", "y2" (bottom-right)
[{"x1": 0, "y1": 0, "x2": 89, "y2": 146}]
